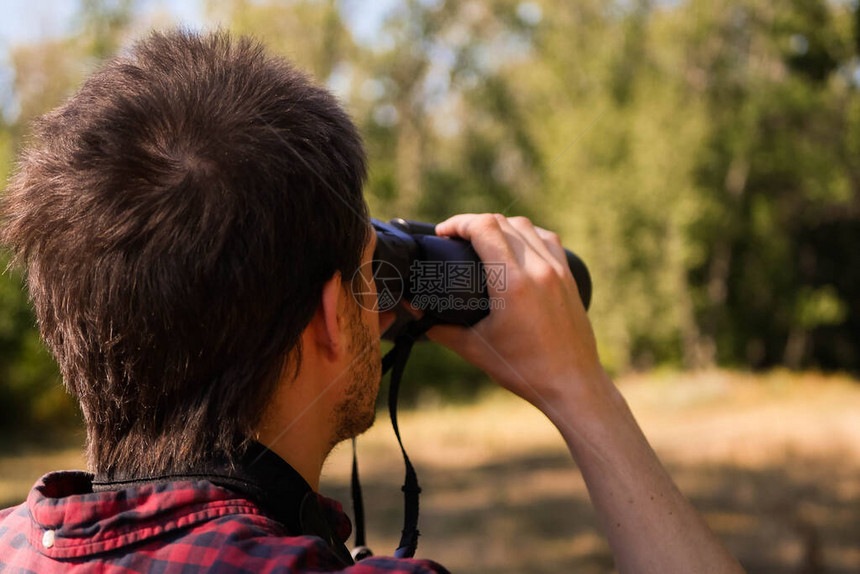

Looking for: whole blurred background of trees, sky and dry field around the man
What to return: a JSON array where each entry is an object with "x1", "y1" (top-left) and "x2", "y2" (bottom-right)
[{"x1": 0, "y1": 0, "x2": 860, "y2": 573}]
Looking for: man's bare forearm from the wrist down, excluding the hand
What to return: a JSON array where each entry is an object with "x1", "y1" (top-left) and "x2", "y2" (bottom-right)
[{"x1": 550, "y1": 375, "x2": 743, "y2": 574}]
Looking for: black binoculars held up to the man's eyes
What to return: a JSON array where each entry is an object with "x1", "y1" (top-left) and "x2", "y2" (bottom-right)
[{"x1": 371, "y1": 219, "x2": 591, "y2": 339}]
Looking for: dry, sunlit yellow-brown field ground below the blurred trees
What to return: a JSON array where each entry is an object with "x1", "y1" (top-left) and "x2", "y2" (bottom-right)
[{"x1": 0, "y1": 372, "x2": 860, "y2": 574}]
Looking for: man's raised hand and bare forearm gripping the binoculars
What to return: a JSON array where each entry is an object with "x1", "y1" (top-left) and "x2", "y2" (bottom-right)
[{"x1": 428, "y1": 214, "x2": 742, "y2": 574}]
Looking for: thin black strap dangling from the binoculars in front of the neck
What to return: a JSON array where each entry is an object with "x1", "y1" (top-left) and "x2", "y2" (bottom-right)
[{"x1": 352, "y1": 315, "x2": 436, "y2": 560}]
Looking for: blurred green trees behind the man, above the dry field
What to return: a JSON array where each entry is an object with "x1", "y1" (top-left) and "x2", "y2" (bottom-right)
[{"x1": 0, "y1": 0, "x2": 860, "y2": 436}]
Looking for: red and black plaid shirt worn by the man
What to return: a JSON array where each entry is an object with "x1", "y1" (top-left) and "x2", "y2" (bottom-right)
[{"x1": 0, "y1": 471, "x2": 446, "y2": 574}]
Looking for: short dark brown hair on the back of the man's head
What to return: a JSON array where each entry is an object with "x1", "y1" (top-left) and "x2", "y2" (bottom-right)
[{"x1": 0, "y1": 31, "x2": 369, "y2": 478}]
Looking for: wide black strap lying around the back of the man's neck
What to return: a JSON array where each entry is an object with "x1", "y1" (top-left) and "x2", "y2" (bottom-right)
[{"x1": 93, "y1": 442, "x2": 353, "y2": 564}]
